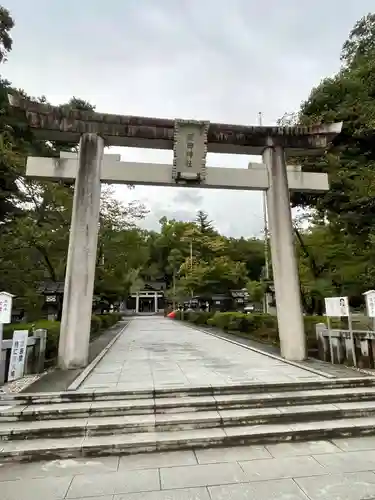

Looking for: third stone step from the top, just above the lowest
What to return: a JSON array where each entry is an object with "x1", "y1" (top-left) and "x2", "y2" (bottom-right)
[{"x1": 0, "y1": 401, "x2": 375, "y2": 442}]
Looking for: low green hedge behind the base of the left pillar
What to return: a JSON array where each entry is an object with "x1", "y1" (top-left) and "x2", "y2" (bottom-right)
[{"x1": 3, "y1": 313, "x2": 121, "y2": 364}]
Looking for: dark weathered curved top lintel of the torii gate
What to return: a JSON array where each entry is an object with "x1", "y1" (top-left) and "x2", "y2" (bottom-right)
[{"x1": 9, "y1": 95, "x2": 342, "y2": 156}]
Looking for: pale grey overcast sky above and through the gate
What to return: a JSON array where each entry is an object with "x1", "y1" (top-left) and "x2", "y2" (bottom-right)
[{"x1": 0, "y1": 0, "x2": 375, "y2": 237}]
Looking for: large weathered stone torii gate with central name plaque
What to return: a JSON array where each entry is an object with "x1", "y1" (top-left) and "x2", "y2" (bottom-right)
[{"x1": 9, "y1": 95, "x2": 342, "y2": 369}]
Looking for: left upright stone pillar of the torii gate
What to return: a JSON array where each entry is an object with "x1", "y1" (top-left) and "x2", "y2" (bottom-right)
[{"x1": 58, "y1": 133, "x2": 104, "y2": 369}]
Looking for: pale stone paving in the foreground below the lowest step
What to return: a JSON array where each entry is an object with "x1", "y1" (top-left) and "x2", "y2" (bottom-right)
[{"x1": 0, "y1": 437, "x2": 375, "y2": 500}]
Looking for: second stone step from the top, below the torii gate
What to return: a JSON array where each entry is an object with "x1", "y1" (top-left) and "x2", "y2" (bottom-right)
[{"x1": 0, "y1": 387, "x2": 375, "y2": 422}]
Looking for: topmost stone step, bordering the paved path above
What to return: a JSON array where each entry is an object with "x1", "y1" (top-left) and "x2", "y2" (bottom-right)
[{"x1": 0, "y1": 376, "x2": 375, "y2": 408}]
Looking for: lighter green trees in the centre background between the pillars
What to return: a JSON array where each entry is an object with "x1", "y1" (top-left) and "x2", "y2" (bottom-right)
[{"x1": 142, "y1": 216, "x2": 264, "y2": 301}]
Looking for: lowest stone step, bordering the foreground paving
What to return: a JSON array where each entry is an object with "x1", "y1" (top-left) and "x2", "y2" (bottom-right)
[{"x1": 0, "y1": 417, "x2": 375, "y2": 461}]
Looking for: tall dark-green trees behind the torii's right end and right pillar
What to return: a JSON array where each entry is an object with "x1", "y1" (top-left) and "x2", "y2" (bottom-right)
[{"x1": 276, "y1": 14, "x2": 375, "y2": 313}]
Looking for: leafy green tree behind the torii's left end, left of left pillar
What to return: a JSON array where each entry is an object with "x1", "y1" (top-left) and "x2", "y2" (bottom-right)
[{"x1": 0, "y1": 93, "x2": 101, "y2": 286}]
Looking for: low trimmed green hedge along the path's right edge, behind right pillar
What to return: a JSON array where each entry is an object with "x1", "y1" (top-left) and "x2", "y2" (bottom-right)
[{"x1": 176, "y1": 311, "x2": 325, "y2": 349}]
